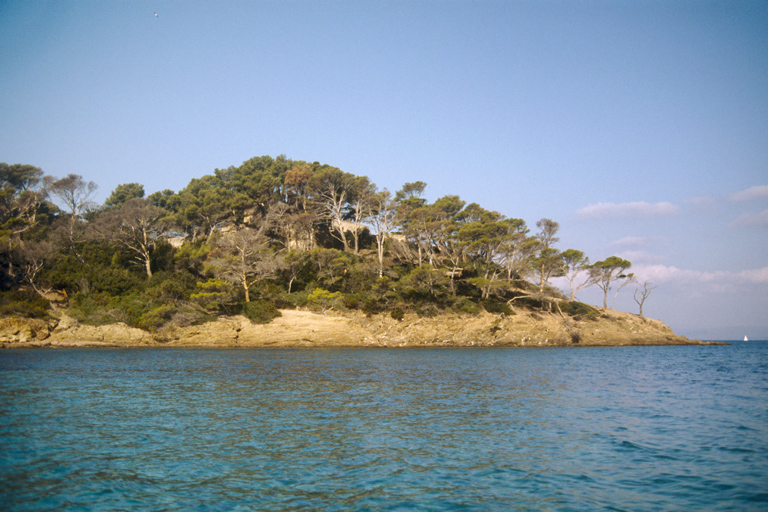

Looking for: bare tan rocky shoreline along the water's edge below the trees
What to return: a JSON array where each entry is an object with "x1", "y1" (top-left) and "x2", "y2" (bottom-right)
[{"x1": 0, "y1": 310, "x2": 722, "y2": 348}]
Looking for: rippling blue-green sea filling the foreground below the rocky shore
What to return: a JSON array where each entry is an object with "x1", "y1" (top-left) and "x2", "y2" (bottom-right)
[{"x1": 0, "y1": 341, "x2": 768, "y2": 512}]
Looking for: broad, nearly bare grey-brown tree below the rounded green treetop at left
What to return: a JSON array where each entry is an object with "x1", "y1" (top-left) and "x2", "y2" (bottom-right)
[{"x1": 91, "y1": 198, "x2": 166, "y2": 278}]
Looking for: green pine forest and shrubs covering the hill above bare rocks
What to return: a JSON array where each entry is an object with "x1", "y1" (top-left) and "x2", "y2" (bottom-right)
[{"x1": 0, "y1": 155, "x2": 653, "y2": 331}]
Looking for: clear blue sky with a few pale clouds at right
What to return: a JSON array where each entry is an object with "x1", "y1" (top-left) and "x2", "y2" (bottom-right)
[{"x1": 0, "y1": 0, "x2": 768, "y2": 339}]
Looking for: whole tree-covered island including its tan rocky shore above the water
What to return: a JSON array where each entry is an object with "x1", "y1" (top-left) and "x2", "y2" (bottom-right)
[{"x1": 0, "y1": 156, "x2": 724, "y2": 347}]
